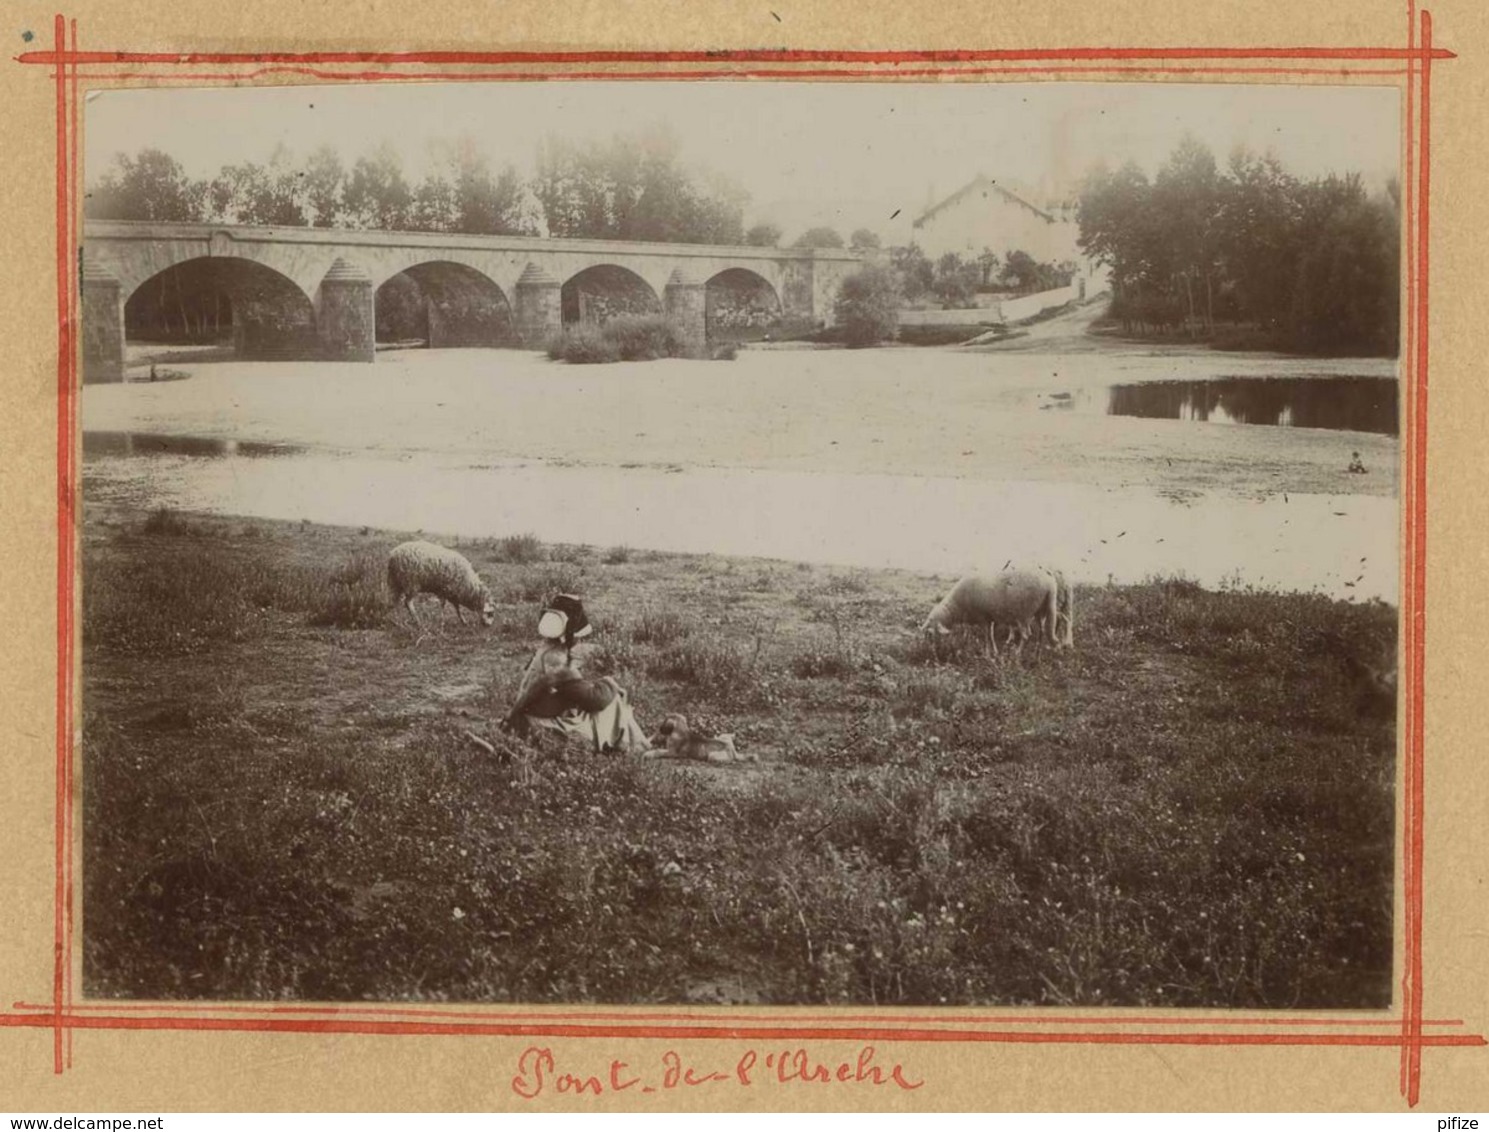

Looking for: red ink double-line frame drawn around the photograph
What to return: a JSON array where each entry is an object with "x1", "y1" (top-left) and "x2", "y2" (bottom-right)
[{"x1": 17, "y1": 0, "x2": 1465, "y2": 1105}]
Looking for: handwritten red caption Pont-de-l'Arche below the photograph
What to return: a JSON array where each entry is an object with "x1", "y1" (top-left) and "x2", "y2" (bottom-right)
[{"x1": 512, "y1": 1046, "x2": 925, "y2": 1101}]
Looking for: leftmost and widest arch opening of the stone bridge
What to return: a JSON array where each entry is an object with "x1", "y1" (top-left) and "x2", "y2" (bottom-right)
[{"x1": 122, "y1": 255, "x2": 317, "y2": 359}]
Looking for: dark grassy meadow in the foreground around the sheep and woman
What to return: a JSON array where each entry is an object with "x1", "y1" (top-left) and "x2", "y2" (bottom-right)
[{"x1": 83, "y1": 506, "x2": 1395, "y2": 1008}]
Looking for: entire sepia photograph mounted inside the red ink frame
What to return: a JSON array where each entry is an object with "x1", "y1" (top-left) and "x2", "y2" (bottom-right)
[{"x1": 79, "y1": 80, "x2": 1403, "y2": 1010}]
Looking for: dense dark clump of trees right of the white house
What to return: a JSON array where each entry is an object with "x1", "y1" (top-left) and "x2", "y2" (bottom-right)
[{"x1": 1080, "y1": 139, "x2": 1401, "y2": 354}]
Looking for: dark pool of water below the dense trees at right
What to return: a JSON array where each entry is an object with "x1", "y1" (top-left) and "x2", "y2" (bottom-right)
[{"x1": 1101, "y1": 377, "x2": 1400, "y2": 436}]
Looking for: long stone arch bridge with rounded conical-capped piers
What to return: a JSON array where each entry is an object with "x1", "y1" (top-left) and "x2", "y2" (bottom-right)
[{"x1": 82, "y1": 220, "x2": 862, "y2": 381}]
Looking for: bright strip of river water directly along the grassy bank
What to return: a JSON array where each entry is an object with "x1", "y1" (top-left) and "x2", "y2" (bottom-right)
[{"x1": 85, "y1": 433, "x2": 1398, "y2": 602}]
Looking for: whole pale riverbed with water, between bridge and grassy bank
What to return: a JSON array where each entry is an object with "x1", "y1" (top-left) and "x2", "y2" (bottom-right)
[{"x1": 82, "y1": 345, "x2": 1400, "y2": 602}]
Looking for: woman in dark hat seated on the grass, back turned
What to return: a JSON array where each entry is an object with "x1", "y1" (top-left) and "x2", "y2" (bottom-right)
[{"x1": 506, "y1": 593, "x2": 651, "y2": 754}]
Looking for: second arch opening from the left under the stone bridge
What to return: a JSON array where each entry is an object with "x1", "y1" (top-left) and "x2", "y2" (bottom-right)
[{"x1": 374, "y1": 259, "x2": 517, "y2": 349}]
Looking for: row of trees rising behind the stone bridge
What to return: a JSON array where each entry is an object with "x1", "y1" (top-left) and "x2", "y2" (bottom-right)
[{"x1": 83, "y1": 128, "x2": 879, "y2": 247}]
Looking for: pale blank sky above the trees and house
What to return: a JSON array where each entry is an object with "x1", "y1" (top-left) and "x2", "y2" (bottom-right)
[{"x1": 83, "y1": 80, "x2": 1401, "y2": 243}]
